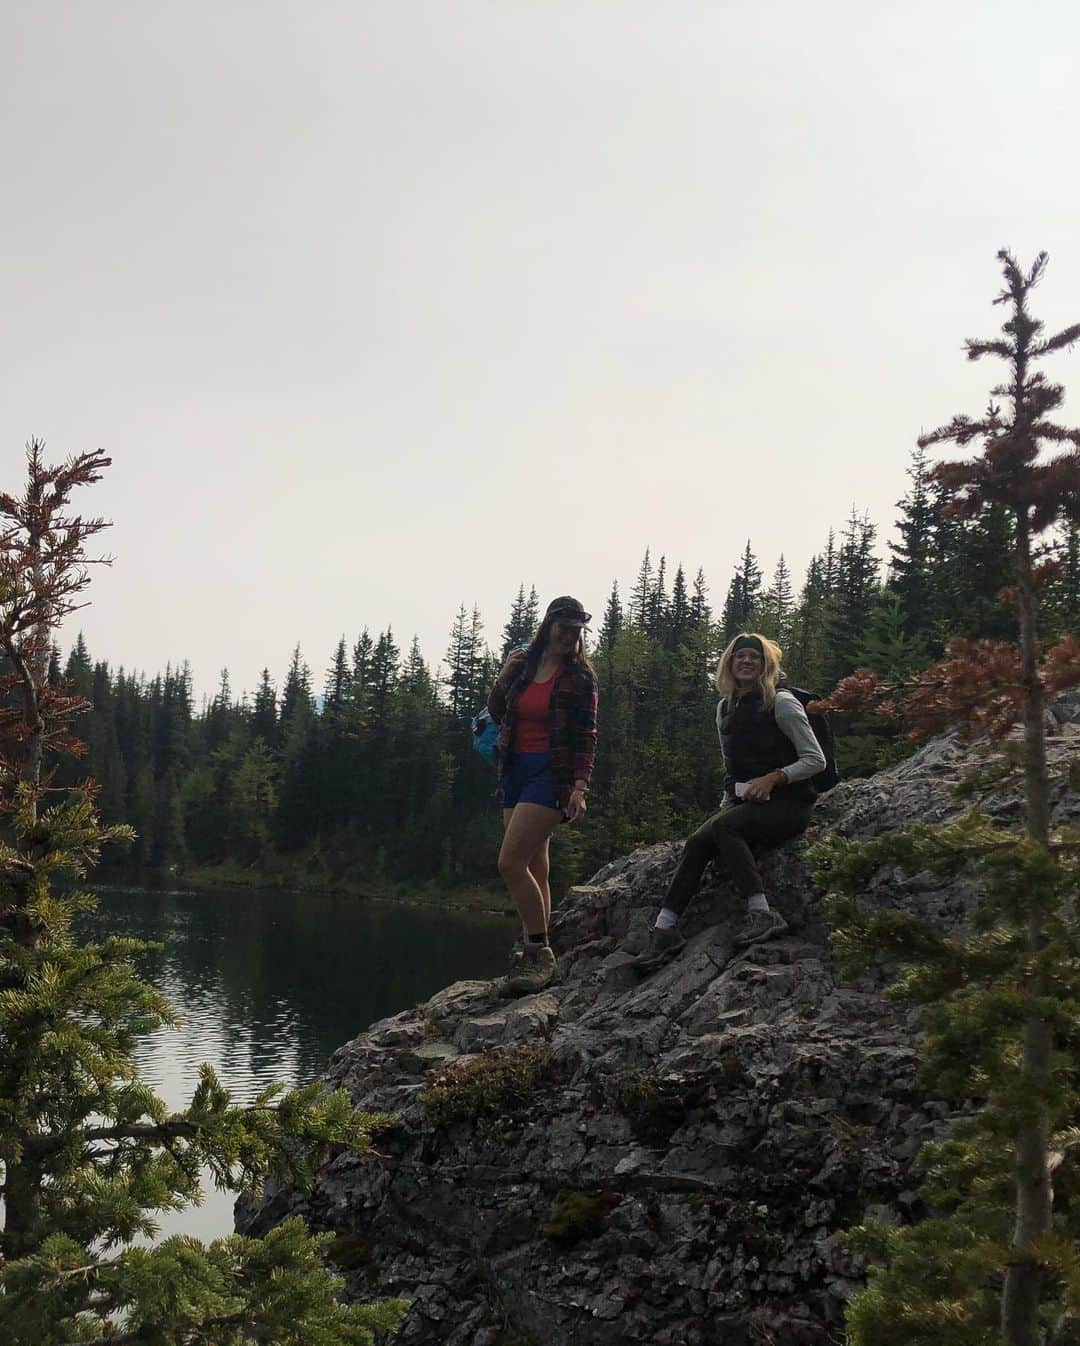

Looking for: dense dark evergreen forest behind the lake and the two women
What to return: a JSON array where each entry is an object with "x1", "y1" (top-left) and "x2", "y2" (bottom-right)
[{"x1": 58, "y1": 450, "x2": 1080, "y2": 891}]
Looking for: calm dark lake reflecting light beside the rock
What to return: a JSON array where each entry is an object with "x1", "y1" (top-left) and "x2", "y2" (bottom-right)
[{"x1": 86, "y1": 888, "x2": 517, "y2": 1238}]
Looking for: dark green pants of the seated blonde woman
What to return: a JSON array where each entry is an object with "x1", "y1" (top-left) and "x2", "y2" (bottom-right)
[{"x1": 664, "y1": 795, "x2": 813, "y2": 915}]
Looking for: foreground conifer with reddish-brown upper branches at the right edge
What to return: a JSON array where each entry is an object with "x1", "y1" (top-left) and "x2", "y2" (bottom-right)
[{"x1": 821, "y1": 252, "x2": 1080, "y2": 1346}]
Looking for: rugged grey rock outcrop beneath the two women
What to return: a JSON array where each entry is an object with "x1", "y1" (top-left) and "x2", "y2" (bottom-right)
[{"x1": 241, "y1": 701, "x2": 1080, "y2": 1346}]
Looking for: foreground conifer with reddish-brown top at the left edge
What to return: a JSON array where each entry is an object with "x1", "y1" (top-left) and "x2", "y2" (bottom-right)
[{"x1": 0, "y1": 441, "x2": 400, "y2": 1346}]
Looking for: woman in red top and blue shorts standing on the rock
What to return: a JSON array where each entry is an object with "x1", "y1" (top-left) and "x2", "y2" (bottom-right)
[{"x1": 487, "y1": 596, "x2": 597, "y2": 992}]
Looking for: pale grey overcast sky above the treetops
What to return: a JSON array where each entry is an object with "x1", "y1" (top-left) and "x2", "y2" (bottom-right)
[{"x1": 0, "y1": 0, "x2": 1080, "y2": 693}]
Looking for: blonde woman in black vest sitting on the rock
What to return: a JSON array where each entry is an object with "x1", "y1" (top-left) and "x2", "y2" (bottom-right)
[{"x1": 634, "y1": 633, "x2": 825, "y2": 972}]
